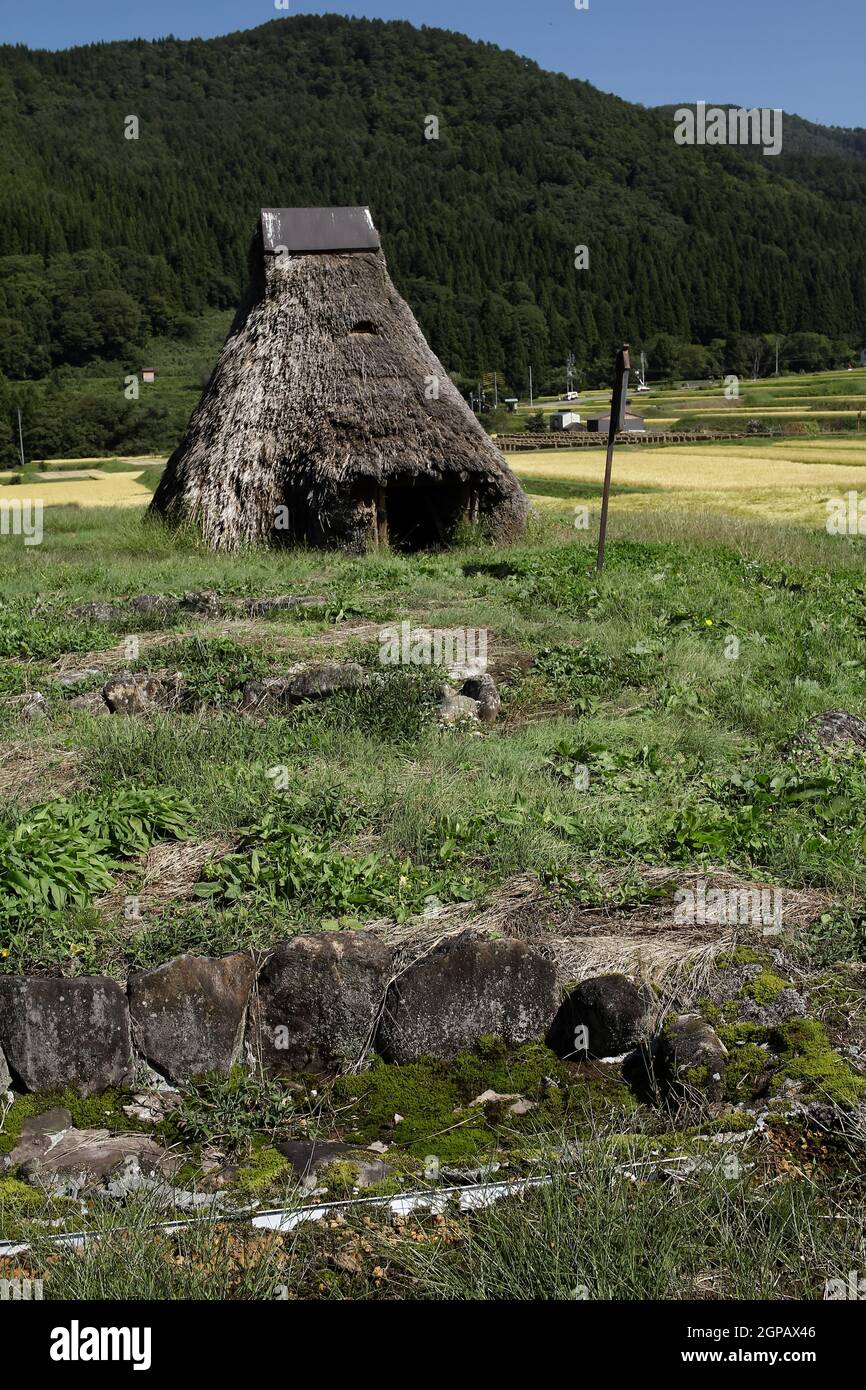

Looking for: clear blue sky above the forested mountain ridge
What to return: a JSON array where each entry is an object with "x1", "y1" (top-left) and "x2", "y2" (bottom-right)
[{"x1": 0, "y1": 0, "x2": 866, "y2": 125}]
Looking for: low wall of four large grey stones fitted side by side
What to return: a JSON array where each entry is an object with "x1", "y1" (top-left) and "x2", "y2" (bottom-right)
[{"x1": 0, "y1": 931, "x2": 560, "y2": 1095}]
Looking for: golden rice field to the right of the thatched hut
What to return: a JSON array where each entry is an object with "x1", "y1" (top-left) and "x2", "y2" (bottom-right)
[{"x1": 513, "y1": 435, "x2": 866, "y2": 527}]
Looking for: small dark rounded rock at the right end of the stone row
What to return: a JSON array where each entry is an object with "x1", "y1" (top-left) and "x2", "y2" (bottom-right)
[{"x1": 548, "y1": 974, "x2": 649, "y2": 1058}]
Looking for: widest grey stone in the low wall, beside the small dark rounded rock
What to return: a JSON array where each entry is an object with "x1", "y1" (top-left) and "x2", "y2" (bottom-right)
[{"x1": 377, "y1": 933, "x2": 559, "y2": 1062}]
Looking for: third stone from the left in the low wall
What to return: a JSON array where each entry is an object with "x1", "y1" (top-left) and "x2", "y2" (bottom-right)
[{"x1": 249, "y1": 931, "x2": 392, "y2": 1072}]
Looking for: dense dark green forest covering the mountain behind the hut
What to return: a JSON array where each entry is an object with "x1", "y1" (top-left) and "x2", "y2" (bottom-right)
[{"x1": 0, "y1": 15, "x2": 866, "y2": 457}]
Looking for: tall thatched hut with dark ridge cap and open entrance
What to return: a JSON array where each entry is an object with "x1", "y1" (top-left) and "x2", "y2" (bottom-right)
[{"x1": 153, "y1": 207, "x2": 527, "y2": 550}]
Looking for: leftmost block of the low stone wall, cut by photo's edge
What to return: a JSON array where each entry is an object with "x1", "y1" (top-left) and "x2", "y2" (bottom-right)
[{"x1": 0, "y1": 976, "x2": 131, "y2": 1095}]
